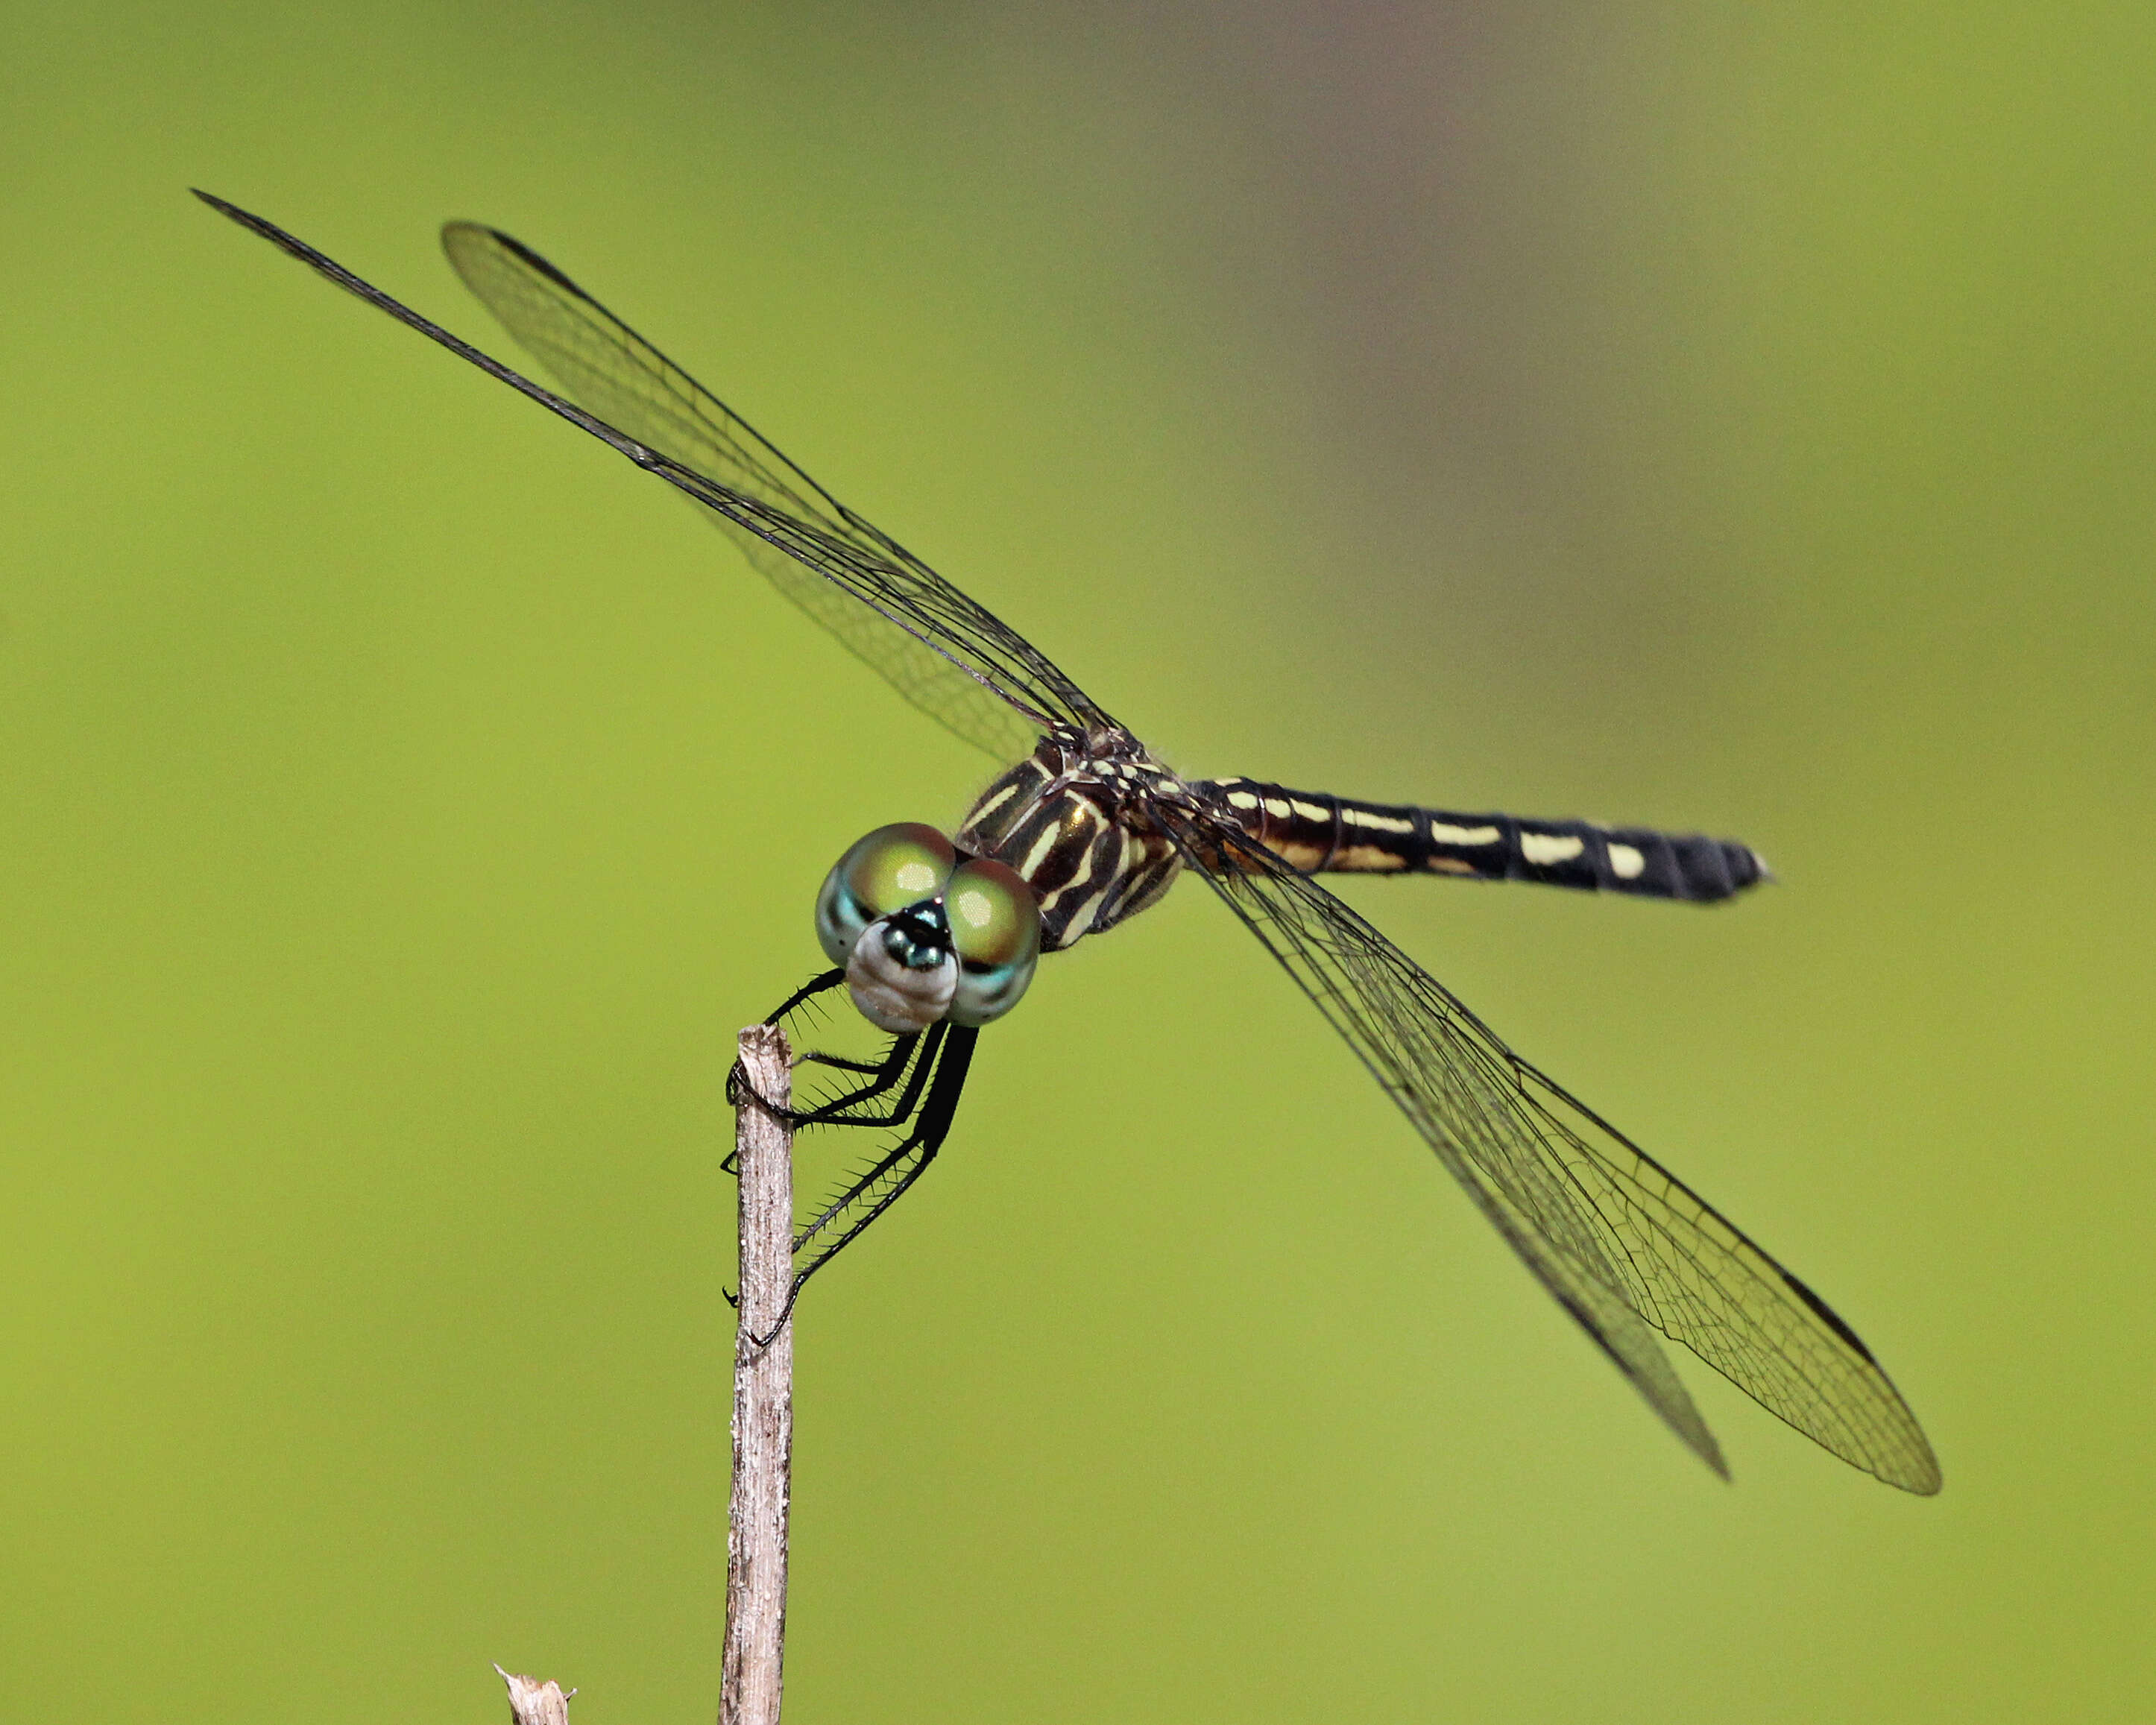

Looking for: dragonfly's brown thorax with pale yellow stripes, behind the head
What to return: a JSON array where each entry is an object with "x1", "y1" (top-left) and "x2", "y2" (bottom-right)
[{"x1": 957, "y1": 727, "x2": 1192, "y2": 951}]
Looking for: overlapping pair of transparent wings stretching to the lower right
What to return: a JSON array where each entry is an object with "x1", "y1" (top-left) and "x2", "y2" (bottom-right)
[{"x1": 1160, "y1": 811, "x2": 1941, "y2": 1495}]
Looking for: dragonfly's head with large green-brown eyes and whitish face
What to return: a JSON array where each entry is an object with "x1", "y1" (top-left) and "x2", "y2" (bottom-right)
[{"x1": 815, "y1": 821, "x2": 1041, "y2": 1033}]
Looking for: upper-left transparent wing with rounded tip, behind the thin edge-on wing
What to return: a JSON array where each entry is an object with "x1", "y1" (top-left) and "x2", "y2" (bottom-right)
[{"x1": 442, "y1": 222, "x2": 1110, "y2": 761}]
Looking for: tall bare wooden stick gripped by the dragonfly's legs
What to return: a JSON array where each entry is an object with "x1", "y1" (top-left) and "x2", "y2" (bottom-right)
[{"x1": 718, "y1": 1024, "x2": 793, "y2": 1725}]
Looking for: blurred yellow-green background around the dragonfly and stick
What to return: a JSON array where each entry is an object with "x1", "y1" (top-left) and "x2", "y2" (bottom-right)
[{"x1": 0, "y1": 0, "x2": 2156, "y2": 1725}]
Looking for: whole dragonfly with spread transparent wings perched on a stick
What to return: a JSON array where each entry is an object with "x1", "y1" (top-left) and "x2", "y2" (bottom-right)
[{"x1": 196, "y1": 192, "x2": 1941, "y2": 1495}]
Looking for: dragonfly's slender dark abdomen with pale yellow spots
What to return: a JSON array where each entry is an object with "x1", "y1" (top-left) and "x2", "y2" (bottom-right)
[{"x1": 1190, "y1": 778, "x2": 1768, "y2": 904}]
